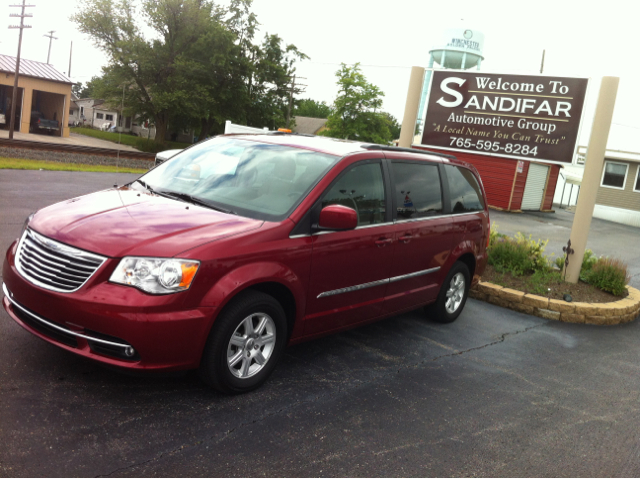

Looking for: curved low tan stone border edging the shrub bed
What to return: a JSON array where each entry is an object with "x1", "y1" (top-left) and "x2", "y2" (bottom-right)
[{"x1": 469, "y1": 281, "x2": 640, "y2": 325}]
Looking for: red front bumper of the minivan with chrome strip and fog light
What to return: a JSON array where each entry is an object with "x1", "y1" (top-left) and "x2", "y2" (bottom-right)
[{"x1": 2, "y1": 243, "x2": 214, "y2": 371}]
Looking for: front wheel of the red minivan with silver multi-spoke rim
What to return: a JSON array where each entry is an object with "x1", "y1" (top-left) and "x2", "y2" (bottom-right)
[{"x1": 199, "y1": 291, "x2": 287, "y2": 394}]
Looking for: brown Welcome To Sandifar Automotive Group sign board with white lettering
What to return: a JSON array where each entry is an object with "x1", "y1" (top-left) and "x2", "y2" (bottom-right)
[{"x1": 422, "y1": 70, "x2": 588, "y2": 163}]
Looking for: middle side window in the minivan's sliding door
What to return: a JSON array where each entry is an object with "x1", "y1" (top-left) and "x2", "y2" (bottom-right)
[{"x1": 392, "y1": 162, "x2": 442, "y2": 220}]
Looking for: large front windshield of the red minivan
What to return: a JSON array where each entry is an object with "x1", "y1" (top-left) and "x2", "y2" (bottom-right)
[{"x1": 140, "y1": 137, "x2": 339, "y2": 221}]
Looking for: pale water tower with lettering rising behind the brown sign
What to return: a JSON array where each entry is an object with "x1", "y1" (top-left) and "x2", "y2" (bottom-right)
[{"x1": 418, "y1": 28, "x2": 484, "y2": 132}]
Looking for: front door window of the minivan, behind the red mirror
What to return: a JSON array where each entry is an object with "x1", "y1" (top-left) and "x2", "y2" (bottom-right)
[{"x1": 322, "y1": 162, "x2": 386, "y2": 226}]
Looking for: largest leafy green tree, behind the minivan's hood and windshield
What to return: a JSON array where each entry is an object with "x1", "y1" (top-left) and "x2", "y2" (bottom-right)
[{"x1": 72, "y1": 0, "x2": 307, "y2": 142}]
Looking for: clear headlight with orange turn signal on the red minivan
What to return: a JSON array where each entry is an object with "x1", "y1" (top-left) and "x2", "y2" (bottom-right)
[{"x1": 109, "y1": 256, "x2": 200, "y2": 294}]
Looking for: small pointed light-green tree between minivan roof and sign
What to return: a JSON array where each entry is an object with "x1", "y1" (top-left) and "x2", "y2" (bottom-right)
[{"x1": 323, "y1": 63, "x2": 393, "y2": 144}]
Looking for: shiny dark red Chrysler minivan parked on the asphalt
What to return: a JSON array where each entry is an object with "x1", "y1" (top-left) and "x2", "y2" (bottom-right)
[{"x1": 2, "y1": 134, "x2": 489, "y2": 393}]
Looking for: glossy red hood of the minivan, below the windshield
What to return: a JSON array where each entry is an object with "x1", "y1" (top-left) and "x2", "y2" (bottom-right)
[{"x1": 29, "y1": 186, "x2": 264, "y2": 257}]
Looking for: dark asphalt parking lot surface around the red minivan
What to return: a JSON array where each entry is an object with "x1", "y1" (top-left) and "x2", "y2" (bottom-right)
[{"x1": 0, "y1": 170, "x2": 640, "y2": 477}]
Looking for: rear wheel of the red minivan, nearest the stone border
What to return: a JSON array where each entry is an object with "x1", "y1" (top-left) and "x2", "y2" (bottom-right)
[{"x1": 426, "y1": 261, "x2": 471, "y2": 323}]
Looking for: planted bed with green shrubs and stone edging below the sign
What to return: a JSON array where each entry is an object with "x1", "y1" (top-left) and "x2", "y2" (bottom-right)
[{"x1": 469, "y1": 223, "x2": 640, "y2": 325}]
